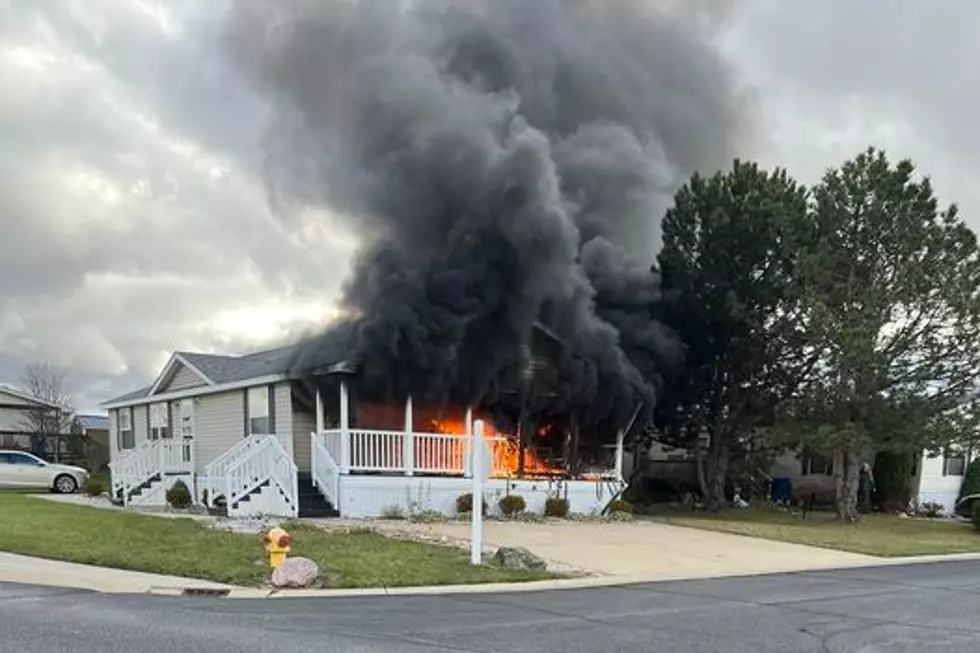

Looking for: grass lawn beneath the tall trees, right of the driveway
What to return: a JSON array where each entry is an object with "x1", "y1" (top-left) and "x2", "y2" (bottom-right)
[{"x1": 649, "y1": 508, "x2": 980, "y2": 557}]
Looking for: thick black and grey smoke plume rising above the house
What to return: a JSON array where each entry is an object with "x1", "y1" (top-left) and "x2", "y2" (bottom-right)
[{"x1": 227, "y1": 0, "x2": 739, "y2": 432}]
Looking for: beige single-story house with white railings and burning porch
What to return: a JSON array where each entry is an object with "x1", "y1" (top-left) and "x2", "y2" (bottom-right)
[{"x1": 103, "y1": 336, "x2": 622, "y2": 517}]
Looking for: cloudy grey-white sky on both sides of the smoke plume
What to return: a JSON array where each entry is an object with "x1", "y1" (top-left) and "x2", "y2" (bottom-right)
[{"x1": 0, "y1": 0, "x2": 980, "y2": 409}]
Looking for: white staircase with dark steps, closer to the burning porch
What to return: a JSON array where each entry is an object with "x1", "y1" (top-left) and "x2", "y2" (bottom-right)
[{"x1": 203, "y1": 435, "x2": 299, "y2": 517}]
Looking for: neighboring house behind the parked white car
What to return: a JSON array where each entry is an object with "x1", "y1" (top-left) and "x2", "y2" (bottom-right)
[{"x1": 0, "y1": 386, "x2": 71, "y2": 459}]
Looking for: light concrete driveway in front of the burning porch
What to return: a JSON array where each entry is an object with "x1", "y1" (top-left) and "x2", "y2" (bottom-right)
[{"x1": 334, "y1": 521, "x2": 881, "y2": 580}]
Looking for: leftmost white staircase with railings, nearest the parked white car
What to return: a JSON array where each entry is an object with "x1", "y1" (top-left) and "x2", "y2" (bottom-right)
[{"x1": 109, "y1": 439, "x2": 192, "y2": 506}]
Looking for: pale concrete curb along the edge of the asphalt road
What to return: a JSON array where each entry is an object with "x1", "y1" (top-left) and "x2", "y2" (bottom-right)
[{"x1": 140, "y1": 553, "x2": 980, "y2": 600}]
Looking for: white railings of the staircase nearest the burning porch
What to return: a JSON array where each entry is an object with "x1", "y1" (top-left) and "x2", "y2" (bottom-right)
[{"x1": 224, "y1": 435, "x2": 299, "y2": 517}]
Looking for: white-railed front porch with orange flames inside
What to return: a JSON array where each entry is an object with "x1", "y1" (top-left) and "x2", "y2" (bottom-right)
[{"x1": 310, "y1": 381, "x2": 624, "y2": 518}]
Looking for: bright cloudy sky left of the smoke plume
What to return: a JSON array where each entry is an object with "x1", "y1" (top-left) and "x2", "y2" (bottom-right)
[{"x1": 0, "y1": 0, "x2": 344, "y2": 406}]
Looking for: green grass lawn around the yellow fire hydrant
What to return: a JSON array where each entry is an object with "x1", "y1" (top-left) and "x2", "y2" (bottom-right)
[{"x1": 0, "y1": 492, "x2": 556, "y2": 587}]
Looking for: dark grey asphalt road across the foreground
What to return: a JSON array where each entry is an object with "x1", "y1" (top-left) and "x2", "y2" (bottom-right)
[{"x1": 0, "y1": 561, "x2": 980, "y2": 653}]
